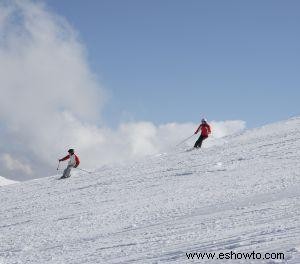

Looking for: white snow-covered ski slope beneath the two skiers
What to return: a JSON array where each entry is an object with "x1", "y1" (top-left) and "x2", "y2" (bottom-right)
[{"x1": 0, "y1": 118, "x2": 300, "y2": 264}]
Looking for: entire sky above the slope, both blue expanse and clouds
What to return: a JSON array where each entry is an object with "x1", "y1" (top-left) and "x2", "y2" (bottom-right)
[{"x1": 0, "y1": 0, "x2": 300, "y2": 180}]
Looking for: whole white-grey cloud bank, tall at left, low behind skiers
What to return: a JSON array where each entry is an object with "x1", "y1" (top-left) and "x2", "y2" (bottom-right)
[{"x1": 0, "y1": 0, "x2": 244, "y2": 180}]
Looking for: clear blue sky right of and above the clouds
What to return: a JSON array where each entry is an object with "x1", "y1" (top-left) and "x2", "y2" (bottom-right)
[{"x1": 46, "y1": 0, "x2": 300, "y2": 127}]
